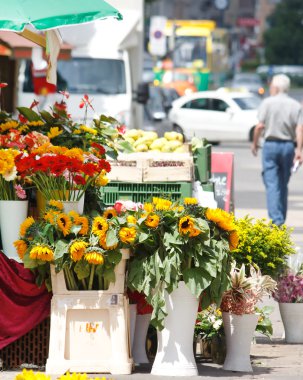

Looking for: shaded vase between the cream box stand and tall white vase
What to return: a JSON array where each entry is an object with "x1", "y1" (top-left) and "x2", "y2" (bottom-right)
[{"x1": 132, "y1": 314, "x2": 151, "y2": 364}]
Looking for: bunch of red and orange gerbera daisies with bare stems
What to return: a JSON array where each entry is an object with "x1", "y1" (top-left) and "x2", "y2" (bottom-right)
[{"x1": 16, "y1": 144, "x2": 110, "y2": 201}]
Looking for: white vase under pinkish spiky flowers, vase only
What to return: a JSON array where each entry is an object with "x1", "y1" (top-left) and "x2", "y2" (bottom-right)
[{"x1": 222, "y1": 312, "x2": 258, "y2": 372}]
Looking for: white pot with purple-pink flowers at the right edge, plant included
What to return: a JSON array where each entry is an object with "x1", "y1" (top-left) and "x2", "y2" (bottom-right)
[{"x1": 273, "y1": 271, "x2": 303, "y2": 343}]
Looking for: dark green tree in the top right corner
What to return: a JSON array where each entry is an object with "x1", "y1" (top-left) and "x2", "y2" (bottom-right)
[{"x1": 264, "y1": 0, "x2": 303, "y2": 65}]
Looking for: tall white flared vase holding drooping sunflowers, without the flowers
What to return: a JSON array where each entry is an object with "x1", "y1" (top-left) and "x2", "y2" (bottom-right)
[{"x1": 151, "y1": 281, "x2": 199, "y2": 376}]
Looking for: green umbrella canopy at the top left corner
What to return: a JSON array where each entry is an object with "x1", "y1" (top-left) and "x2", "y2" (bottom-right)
[{"x1": 0, "y1": 0, "x2": 122, "y2": 32}]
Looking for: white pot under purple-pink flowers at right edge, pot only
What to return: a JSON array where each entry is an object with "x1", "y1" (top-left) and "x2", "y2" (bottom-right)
[{"x1": 279, "y1": 303, "x2": 303, "y2": 343}]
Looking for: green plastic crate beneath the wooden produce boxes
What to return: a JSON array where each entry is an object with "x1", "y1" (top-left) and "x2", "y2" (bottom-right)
[{"x1": 101, "y1": 182, "x2": 192, "y2": 206}]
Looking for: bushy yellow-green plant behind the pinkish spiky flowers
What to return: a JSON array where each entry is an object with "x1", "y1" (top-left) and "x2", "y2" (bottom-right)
[{"x1": 232, "y1": 216, "x2": 295, "y2": 278}]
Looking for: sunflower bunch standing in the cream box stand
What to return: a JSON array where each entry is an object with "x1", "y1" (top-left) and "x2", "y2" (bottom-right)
[{"x1": 14, "y1": 200, "x2": 138, "y2": 290}]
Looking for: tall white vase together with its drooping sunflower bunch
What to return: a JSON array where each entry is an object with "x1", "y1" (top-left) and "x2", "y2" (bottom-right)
[{"x1": 128, "y1": 202, "x2": 237, "y2": 376}]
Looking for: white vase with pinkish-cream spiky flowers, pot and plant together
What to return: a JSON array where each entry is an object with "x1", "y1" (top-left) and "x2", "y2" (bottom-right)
[{"x1": 221, "y1": 264, "x2": 276, "y2": 372}]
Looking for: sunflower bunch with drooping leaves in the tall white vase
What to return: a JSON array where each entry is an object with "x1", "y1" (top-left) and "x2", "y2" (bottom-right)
[{"x1": 128, "y1": 198, "x2": 237, "y2": 329}]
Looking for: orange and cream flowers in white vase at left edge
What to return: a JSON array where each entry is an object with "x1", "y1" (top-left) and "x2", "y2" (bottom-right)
[{"x1": 0, "y1": 149, "x2": 26, "y2": 201}]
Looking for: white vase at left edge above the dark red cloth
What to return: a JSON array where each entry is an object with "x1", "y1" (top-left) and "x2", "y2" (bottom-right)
[{"x1": 0, "y1": 200, "x2": 28, "y2": 261}]
